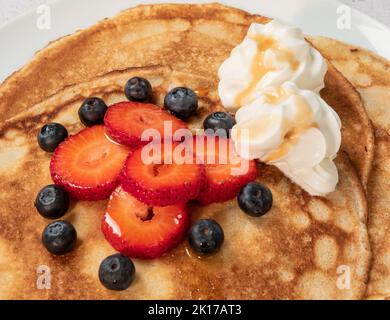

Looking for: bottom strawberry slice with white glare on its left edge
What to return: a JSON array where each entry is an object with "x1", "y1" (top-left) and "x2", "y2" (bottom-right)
[{"x1": 102, "y1": 187, "x2": 190, "y2": 259}]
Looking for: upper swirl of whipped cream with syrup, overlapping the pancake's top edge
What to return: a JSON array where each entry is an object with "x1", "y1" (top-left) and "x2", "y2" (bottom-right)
[{"x1": 219, "y1": 20, "x2": 327, "y2": 110}]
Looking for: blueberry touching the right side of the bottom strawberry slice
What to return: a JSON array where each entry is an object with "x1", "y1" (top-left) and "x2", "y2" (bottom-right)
[{"x1": 188, "y1": 220, "x2": 225, "y2": 255}]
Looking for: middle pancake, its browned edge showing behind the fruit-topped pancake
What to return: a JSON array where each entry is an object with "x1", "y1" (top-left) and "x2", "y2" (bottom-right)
[{"x1": 0, "y1": 4, "x2": 374, "y2": 186}]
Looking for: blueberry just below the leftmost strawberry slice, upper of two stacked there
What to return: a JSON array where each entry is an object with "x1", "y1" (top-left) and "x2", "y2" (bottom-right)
[{"x1": 35, "y1": 185, "x2": 69, "y2": 220}]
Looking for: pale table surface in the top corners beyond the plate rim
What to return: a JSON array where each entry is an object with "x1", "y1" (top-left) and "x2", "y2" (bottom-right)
[{"x1": 0, "y1": 0, "x2": 390, "y2": 27}]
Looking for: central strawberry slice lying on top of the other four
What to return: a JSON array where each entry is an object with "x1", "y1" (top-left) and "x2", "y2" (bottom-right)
[{"x1": 120, "y1": 143, "x2": 204, "y2": 207}]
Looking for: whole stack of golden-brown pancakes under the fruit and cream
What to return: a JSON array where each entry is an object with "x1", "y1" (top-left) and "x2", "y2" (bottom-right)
[{"x1": 0, "y1": 4, "x2": 390, "y2": 299}]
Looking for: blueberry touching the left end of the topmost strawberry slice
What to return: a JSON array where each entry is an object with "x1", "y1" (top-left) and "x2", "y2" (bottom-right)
[{"x1": 79, "y1": 98, "x2": 108, "y2": 127}]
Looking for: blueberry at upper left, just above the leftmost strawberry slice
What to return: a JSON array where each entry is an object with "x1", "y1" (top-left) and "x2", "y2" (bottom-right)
[{"x1": 38, "y1": 123, "x2": 68, "y2": 152}]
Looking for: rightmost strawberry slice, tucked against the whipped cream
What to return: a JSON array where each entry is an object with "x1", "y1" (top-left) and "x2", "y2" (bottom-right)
[{"x1": 193, "y1": 135, "x2": 257, "y2": 205}]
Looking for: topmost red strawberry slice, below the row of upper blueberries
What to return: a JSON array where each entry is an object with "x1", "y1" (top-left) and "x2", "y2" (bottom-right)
[{"x1": 104, "y1": 102, "x2": 188, "y2": 148}]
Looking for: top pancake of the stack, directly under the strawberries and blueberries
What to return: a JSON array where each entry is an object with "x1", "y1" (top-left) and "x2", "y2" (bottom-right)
[{"x1": 0, "y1": 66, "x2": 370, "y2": 299}]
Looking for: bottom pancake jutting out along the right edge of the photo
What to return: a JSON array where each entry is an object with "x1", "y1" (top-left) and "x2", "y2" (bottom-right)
[{"x1": 311, "y1": 37, "x2": 390, "y2": 299}]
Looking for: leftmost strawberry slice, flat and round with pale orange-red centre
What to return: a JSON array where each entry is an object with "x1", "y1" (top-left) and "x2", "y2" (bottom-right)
[{"x1": 50, "y1": 126, "x2": 130, "y2": 201}]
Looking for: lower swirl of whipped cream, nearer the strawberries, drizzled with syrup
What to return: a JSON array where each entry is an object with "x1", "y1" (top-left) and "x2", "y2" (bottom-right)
[{"x1": 232, "y1": 82, "x2": 341, "y2": 196}]
